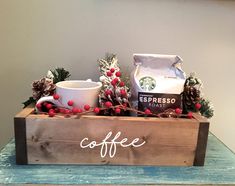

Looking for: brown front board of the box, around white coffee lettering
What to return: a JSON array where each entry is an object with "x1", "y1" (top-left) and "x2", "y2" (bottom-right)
[{"x1": 26, "y1": 117, "x2": 199, "y2": 166}]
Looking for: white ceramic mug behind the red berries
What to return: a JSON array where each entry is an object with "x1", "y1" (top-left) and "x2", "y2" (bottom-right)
[{"x1": 37, "y1": 79, "x2": 102, "y2": 109}]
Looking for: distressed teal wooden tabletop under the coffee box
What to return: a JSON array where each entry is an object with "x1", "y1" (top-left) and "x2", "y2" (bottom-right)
[{"x1": 0, "y1": 134, "x2": 235, "y2": 185}]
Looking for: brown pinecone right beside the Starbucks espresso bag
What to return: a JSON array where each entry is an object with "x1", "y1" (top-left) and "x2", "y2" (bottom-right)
[{"x1": 183, "y1": 85, "x2": 200, "y2": 110}]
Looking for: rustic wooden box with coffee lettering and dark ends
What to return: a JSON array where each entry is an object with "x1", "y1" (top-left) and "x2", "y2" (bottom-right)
[{"x1": 14, "y1": 107, "x2": 209, "y2": 166}]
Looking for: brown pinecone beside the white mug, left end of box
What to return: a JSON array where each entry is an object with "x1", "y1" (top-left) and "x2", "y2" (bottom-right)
[{"x1": 32, "y1": 78, "x2": 55, "y2": 100}]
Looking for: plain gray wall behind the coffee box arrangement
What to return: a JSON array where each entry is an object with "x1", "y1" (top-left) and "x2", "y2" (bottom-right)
[{"x1": 0, "y1": 0, "x2": 235, "y2": 151}]
